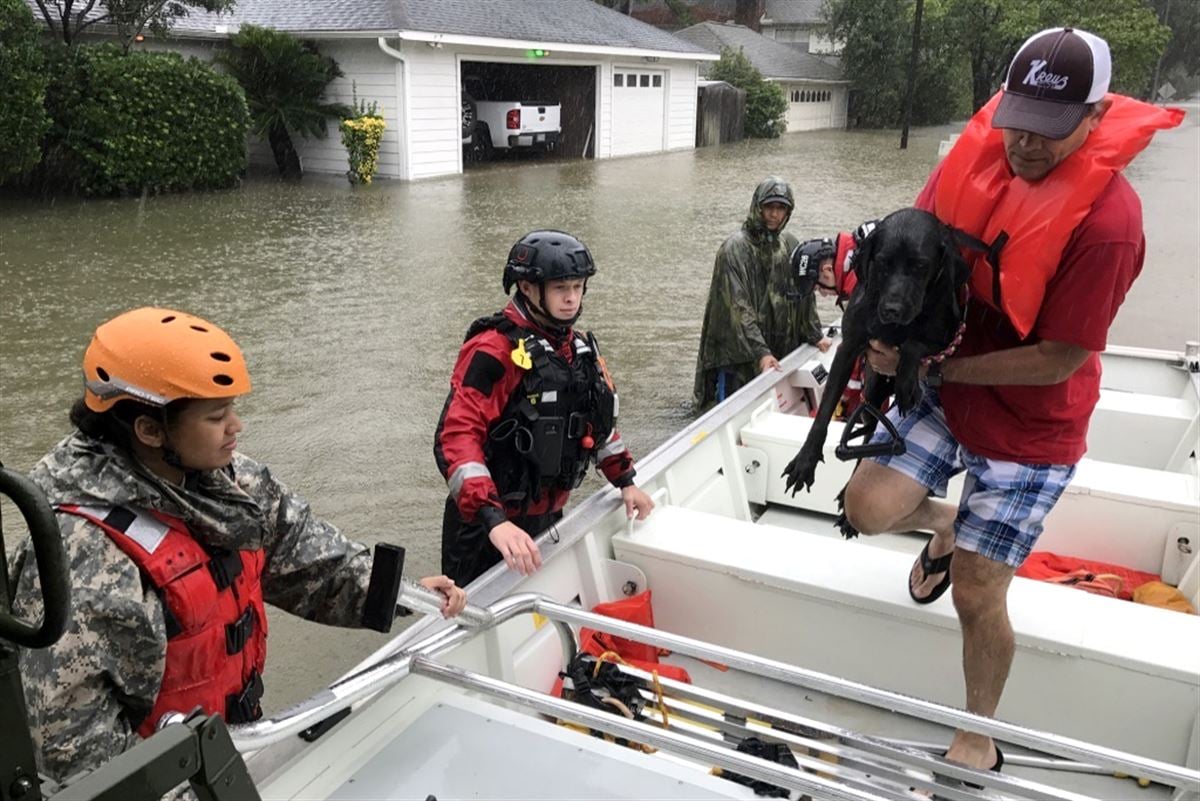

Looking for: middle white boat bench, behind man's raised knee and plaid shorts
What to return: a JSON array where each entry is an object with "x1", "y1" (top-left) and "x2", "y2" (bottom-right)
[{"x1": 740, "y1": 410, "x2": 1200, "y2": 584}]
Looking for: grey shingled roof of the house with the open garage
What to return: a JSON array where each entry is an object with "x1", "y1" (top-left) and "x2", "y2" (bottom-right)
[{"x1": 26, "y1": 0, "x2": 706, "y2": 56}]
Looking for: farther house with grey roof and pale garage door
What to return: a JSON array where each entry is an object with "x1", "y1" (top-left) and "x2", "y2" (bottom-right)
[{"x1": 676, "y1": 23, "x2": 850, "y2": 133}]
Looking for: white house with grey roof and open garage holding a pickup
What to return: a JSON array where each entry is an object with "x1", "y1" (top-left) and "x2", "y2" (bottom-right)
[{"x1": 30, "y1": 0, "x2": 716, "y2": 180}]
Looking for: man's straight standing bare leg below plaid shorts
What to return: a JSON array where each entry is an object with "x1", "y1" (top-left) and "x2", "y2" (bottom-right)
[{"x1": 946, "y1": 548, "x2": 1015, "y2": 770}]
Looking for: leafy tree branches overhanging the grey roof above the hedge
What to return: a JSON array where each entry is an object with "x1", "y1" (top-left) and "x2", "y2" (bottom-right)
[{"x1": 34, "y1": 0, "x2": 235, "y2": 50}]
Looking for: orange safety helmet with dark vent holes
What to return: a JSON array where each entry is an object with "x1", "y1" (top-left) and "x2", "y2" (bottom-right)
[{"x1": 83, "y1": 307, "x2": 250, "y2": 411}]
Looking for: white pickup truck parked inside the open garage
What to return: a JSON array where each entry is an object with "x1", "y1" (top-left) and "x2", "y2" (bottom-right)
[{"x1": 462, "y1": 78, "x2": 563, "y2": 158}]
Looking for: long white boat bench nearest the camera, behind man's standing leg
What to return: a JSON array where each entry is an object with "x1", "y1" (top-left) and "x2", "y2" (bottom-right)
[{"x1": 613, "y1": 502, "x2": 1200, "y2": 764}]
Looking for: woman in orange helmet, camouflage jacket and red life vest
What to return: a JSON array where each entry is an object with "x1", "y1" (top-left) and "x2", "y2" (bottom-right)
[{"x1": 5, "y1": 308, "x2": 466, "y2": 782}]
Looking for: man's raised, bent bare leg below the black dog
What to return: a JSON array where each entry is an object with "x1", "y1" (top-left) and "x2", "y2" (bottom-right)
[{"x1": 846, "y1": 462, "x2": 958, "y2": 597}]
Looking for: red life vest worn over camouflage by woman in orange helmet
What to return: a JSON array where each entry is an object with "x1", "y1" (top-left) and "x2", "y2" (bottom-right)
[{"x1": 58, "y1": 505, "x2": 266, "y2": 737}]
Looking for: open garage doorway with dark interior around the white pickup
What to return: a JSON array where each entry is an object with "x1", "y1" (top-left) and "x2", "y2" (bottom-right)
[{"x1": 460, "y1": 61, "x2": 596, "y2": 165}]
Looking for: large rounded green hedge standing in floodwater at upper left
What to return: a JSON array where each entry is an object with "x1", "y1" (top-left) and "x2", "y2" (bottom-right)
[{"x1": 47, "y1": 44, "x2": 247, "y2": 194}]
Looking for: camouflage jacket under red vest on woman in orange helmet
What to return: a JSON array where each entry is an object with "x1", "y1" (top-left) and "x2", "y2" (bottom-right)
[{"x1": 11, "y1": 432, "x2": 371, "y2": 782}]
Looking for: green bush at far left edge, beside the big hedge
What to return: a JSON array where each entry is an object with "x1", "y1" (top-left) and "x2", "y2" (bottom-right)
[{"x1": 0, "y1": 0, "x2": 50, "y2": 181}]
